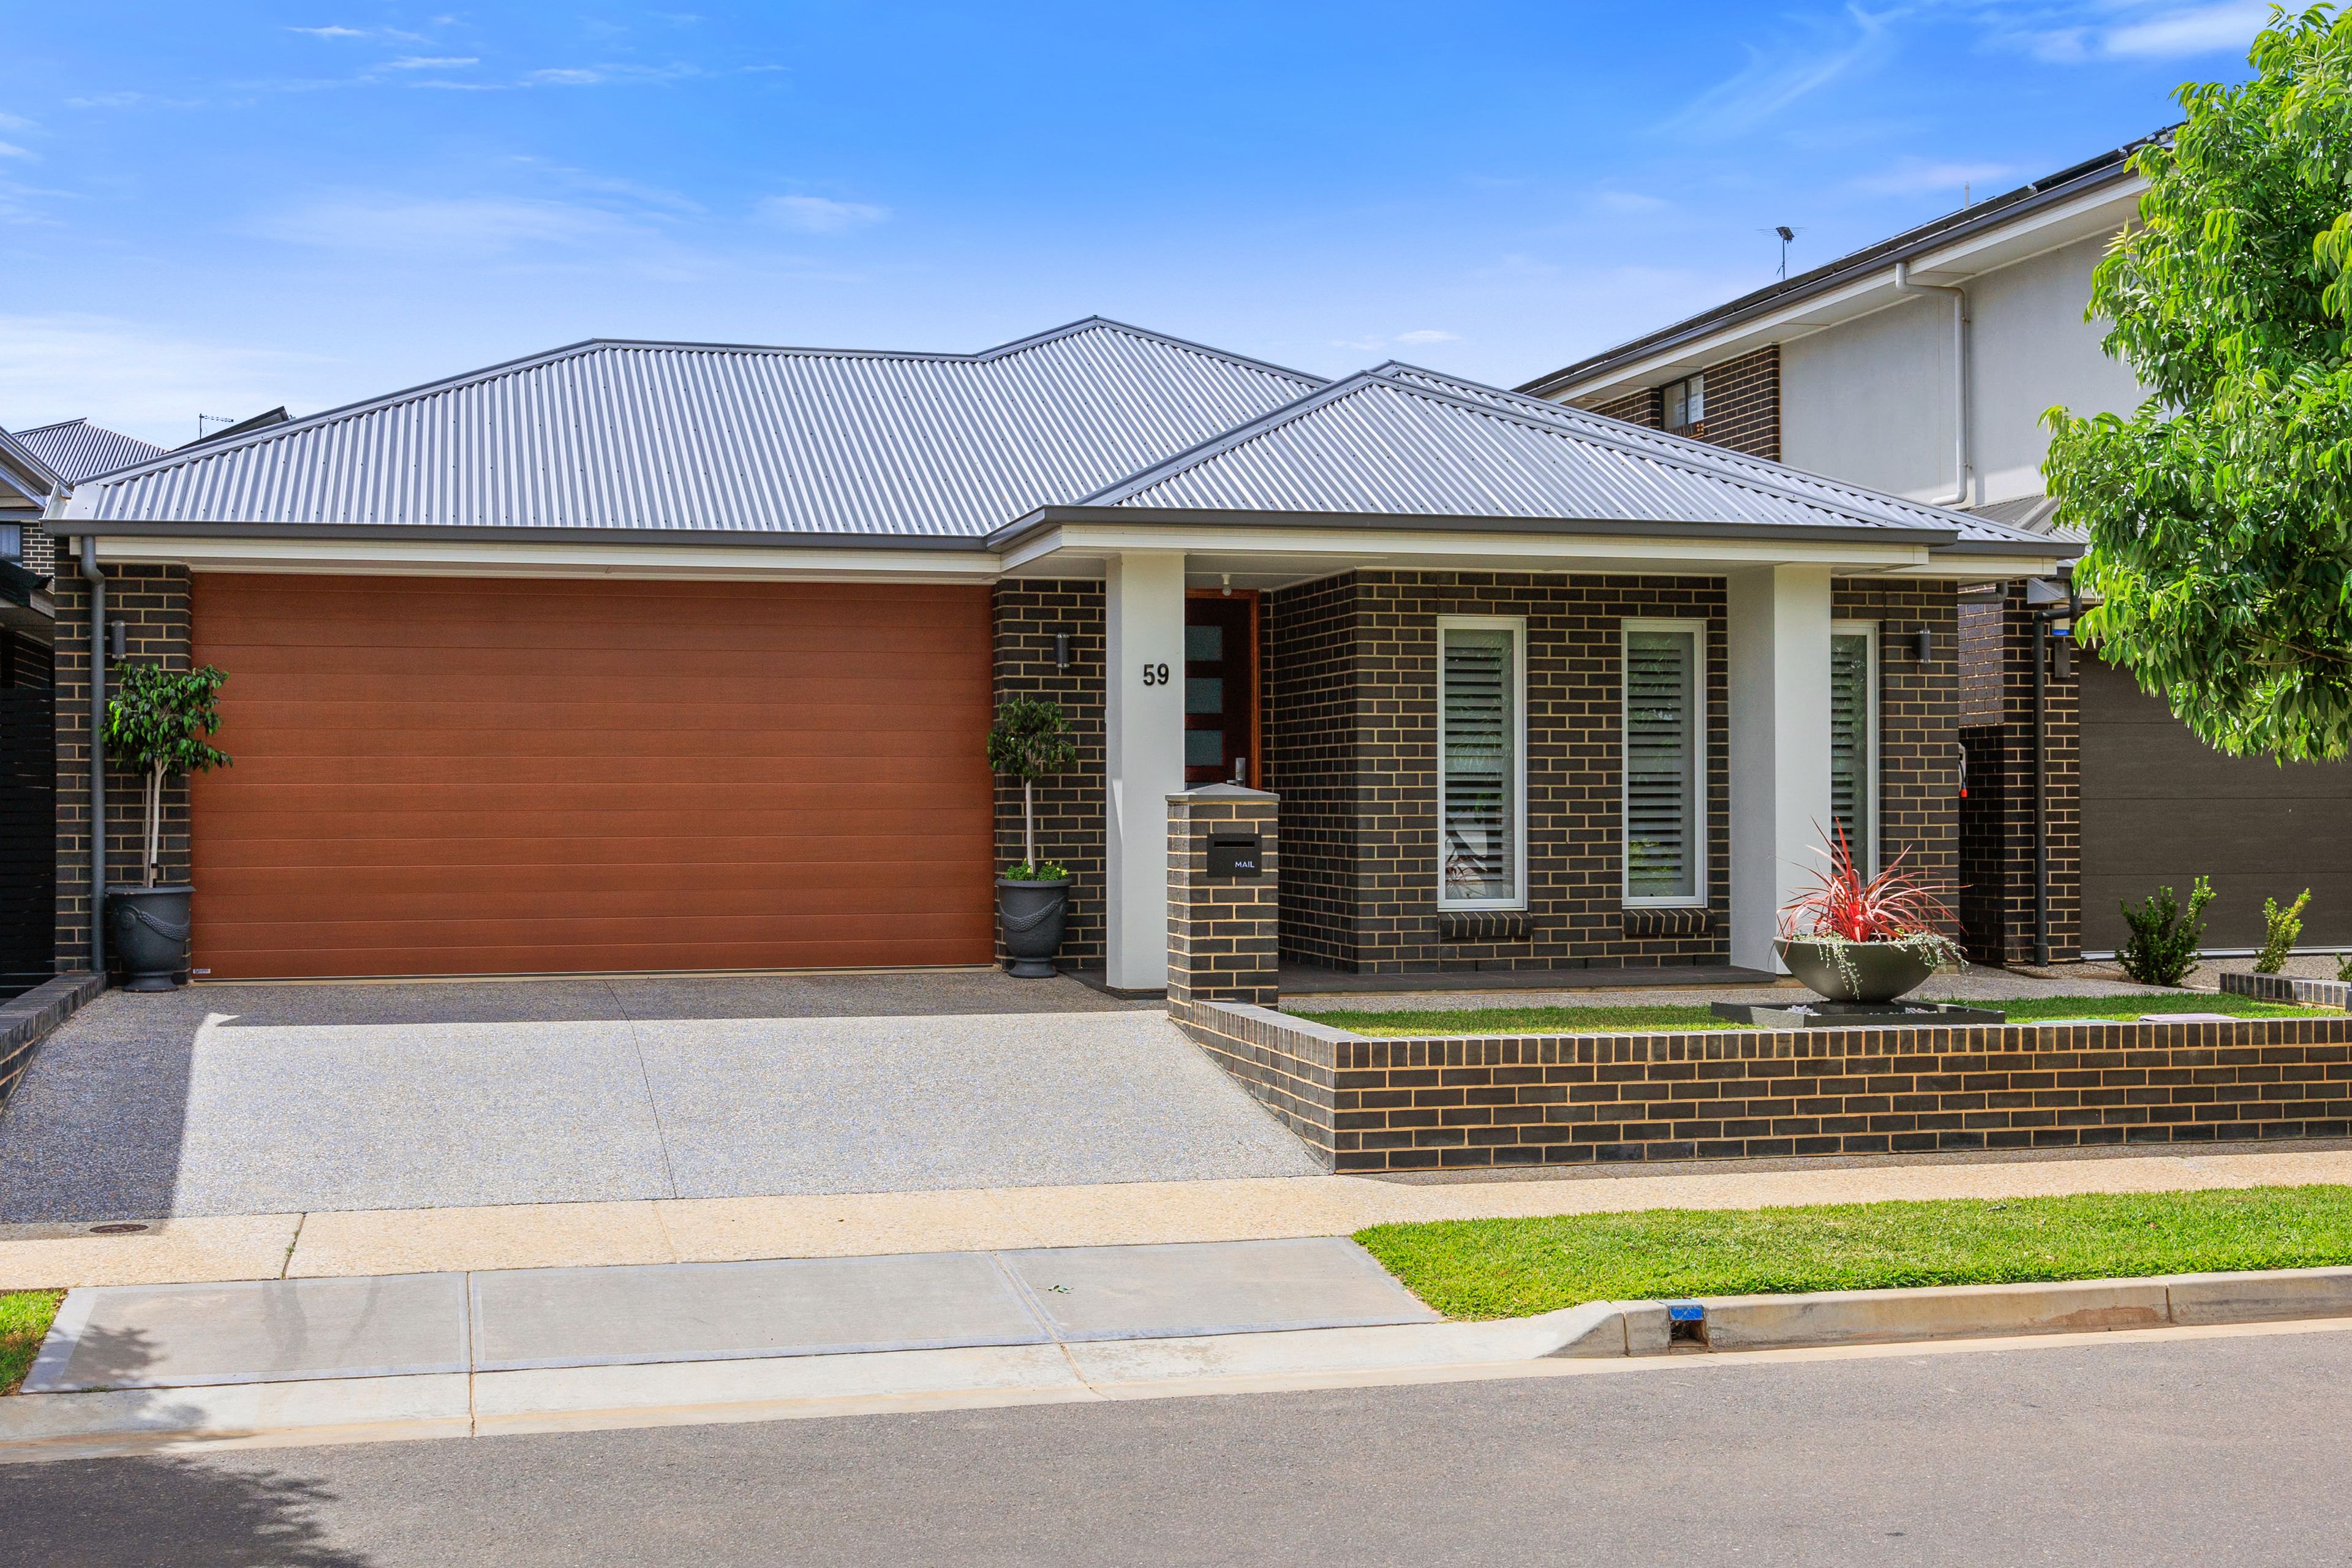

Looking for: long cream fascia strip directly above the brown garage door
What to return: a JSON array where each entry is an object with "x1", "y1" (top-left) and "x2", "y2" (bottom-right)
[{"x1": 85, "y1": 533, "x2": 1000, "y2": 583}]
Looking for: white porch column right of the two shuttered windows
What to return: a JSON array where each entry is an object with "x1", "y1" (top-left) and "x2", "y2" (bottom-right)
[{"x1": 1727, "y1": 567, "x2": 1830, "y2": 973}]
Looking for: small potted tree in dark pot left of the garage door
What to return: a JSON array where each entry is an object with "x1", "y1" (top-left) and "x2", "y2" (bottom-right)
[{"x1": 106, "y1": 665, "x2": 228, "y2": 992}]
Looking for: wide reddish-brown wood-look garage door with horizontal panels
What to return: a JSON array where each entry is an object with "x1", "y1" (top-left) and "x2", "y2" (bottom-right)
[{"x1": 193, "y1": 573, "x2": 992, "y2": 978}]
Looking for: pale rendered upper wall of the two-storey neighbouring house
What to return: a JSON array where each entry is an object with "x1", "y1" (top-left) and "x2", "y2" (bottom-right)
[{"x1": 1781, "y1": 239, "x2": 2140, "y2": 505}]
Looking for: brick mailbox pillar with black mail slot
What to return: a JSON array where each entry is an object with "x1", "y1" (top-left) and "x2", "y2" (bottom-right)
[{"x1": 1169, "y1": 785, "x2": 1280, "y2": 1018}]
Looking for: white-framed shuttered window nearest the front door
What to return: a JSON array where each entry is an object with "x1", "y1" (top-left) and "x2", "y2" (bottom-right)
[{"x1": 1437, "y1": 620, "x2": 1524, "y2": 910}]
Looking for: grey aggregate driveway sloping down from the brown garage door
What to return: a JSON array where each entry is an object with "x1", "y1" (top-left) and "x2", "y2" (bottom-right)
[{"x1": 0, "y1": 971, "x2": 1317, "y2": 1223}]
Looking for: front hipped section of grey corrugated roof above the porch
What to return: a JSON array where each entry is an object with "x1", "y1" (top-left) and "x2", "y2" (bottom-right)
[{"x1": 1084, "y1": 364, "x2": 2049, "y2": 552}]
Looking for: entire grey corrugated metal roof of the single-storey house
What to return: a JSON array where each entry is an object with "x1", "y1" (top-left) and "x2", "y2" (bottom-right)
[{"x1": 66, "y1": 317, "x2": 2046, "y2": 550}]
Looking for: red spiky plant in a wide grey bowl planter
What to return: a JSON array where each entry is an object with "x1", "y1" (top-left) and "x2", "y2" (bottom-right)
[{"x1": 1773, "y1": 830, "x2": 1962, "y2": 1004}]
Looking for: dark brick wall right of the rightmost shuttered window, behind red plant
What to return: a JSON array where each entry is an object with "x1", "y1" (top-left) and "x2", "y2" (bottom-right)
[{"x1": 1830, "y1": 578, "x2": 1962, "y2": 936}]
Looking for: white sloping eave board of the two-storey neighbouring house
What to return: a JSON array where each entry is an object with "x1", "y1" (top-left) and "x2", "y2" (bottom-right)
[{"x1": 1552, "y1": 174, "x2": 2147, "y2": 409}]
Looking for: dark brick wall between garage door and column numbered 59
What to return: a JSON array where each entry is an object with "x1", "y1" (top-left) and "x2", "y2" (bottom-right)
[{"x1": 995, "y1": 578, "x2": 1106, "y2": 966}]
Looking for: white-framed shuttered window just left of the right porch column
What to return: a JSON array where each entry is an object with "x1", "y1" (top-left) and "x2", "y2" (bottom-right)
[{"x1": 1625, "y1": 620, "x2": 1708, "y2": 905}]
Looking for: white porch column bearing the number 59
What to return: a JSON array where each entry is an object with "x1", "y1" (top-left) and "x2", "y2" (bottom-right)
[{"x1": 1103, "y1": 550, "x2": 1185, "y2": 992}]
